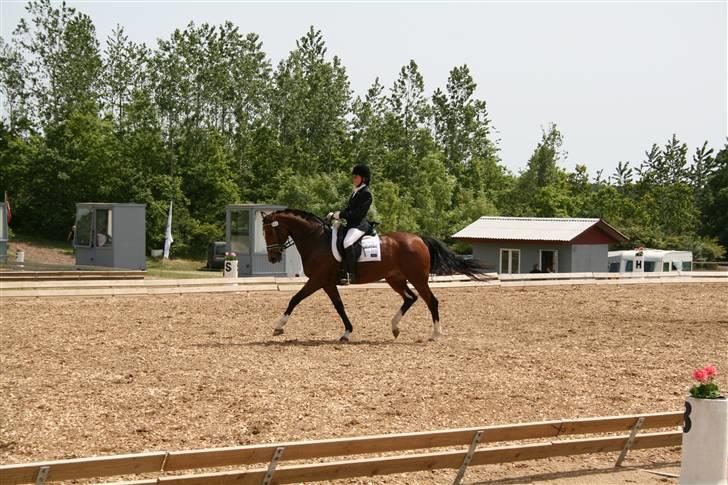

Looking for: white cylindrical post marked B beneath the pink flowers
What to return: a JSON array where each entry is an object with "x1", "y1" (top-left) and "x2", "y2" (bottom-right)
[{"x1": 680, "y1": 397, "x2": 728, "y2": 485}]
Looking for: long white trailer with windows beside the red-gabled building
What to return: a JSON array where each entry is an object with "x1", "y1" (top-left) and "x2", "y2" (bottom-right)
[{"x1": 609, "y1": 249, "x2": 693, "y2": 273}]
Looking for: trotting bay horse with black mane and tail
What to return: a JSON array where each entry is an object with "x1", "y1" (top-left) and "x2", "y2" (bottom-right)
[{"x1": 263, "y1": 209, "x2": 489, "y2": 343}]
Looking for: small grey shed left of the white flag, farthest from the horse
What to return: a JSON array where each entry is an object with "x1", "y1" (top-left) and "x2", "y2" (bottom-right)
[{"x1": 74, "y1": 202, "x2": 147, "y2": 269}]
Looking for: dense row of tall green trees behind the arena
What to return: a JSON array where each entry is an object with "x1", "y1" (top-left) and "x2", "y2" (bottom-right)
[{"x1": 0, "y1": 0, "x2": 728, "y2": 260}]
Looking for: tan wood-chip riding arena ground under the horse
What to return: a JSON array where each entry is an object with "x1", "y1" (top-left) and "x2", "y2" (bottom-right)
[{"x1": 0, "y1": 283, "x2": 728, "y2": 484}]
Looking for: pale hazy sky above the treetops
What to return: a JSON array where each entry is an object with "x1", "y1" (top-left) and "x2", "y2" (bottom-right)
[{"x1": 0, "y1": 0, "x2": 728, "y2": 176}]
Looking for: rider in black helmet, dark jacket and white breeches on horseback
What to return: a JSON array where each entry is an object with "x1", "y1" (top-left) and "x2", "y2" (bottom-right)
[{"x1": 328, "y1": 164, "x2": 372, "y2": 285}]
